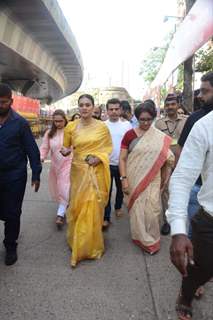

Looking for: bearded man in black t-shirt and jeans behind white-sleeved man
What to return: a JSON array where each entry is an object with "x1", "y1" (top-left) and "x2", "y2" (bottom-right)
[{"x1": 178, "y1": 72, "x2": 213, "y2": 239}]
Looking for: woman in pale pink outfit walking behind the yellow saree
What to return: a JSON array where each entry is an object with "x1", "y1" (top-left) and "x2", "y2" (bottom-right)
[{"x1": 40, "y1": 110, "x2": 71, "y2": 229}]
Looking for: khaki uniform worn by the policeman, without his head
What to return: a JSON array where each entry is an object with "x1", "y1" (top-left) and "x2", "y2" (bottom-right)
[{"x1": 155, "y1": 115, "x2": 187, "y2": 222}]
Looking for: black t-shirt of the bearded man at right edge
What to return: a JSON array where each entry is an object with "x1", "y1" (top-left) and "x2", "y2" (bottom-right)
[{"x1": 178, "y1": 105, "x2": 213, "y2": 185}]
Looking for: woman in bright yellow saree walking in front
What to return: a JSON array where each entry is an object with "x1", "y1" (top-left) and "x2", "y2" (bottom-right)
[{"x1": 61, "y1": 94, "x2": 112, "y2": 267}]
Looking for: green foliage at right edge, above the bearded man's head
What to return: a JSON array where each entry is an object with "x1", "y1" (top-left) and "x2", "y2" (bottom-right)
[{"x1": 195, "y1": 45, "x2": 213, "y2": 72}]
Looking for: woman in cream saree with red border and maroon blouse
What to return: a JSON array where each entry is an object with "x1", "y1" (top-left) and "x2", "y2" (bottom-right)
[{"x1": 120, "y1": 102, "x2": 174, "y2": 254}]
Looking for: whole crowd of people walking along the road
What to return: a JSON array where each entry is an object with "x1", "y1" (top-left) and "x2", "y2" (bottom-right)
[{"x1": 0, "y1": 72, "x2": 213, "y2": 320}]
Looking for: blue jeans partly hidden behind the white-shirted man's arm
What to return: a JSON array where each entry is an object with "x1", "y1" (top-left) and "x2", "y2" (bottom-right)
[{"x1": 188, "y1": 184, "x2": 201, "y2": 239}]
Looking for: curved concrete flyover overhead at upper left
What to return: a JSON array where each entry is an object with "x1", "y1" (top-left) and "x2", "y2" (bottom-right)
[{"x1": 0, "y1": 0, "x2": 83, "y2": 103}]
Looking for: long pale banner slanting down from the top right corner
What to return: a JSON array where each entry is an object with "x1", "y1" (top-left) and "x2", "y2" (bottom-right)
[{"x1": 151, "y1": 0, "x2": 213, "y2": 88}]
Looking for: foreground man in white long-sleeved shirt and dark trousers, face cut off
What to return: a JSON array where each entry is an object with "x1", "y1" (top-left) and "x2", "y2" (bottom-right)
[{"x1": 167, "y1": 109, "x2": 213, "y2": 319}]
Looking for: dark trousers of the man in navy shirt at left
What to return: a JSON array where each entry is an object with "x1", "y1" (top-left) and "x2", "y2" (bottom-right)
[{"x1": 0, "y1": 174, "x2": 27, "y2": 250}]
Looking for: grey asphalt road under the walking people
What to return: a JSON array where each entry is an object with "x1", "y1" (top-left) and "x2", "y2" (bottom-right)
[{"x1": 0, "y1": 163, "x2": 213, "y2": 320}]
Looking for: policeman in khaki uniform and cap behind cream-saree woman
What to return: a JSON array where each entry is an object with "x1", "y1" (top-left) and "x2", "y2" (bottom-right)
[{"x1": 155, "y1": 94, "x2": 187, "y2": 235}]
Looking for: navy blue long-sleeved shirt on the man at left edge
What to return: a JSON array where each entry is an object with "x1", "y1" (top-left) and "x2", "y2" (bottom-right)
[{"x1": 0, "y1": 109, "x2": 42, "y2": 182}]
